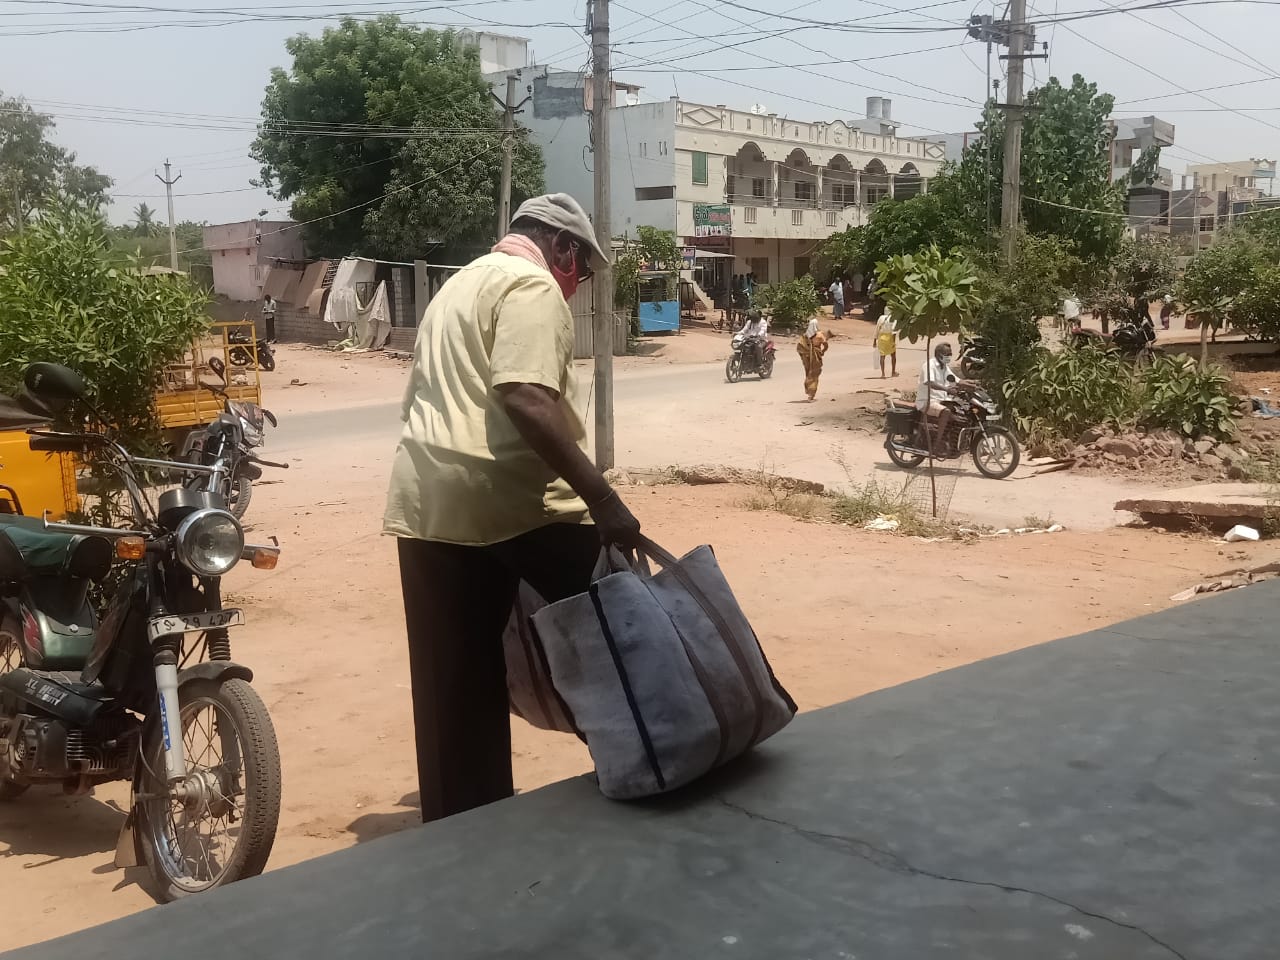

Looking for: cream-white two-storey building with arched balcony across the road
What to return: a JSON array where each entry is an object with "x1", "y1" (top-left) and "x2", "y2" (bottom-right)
[{"x1": 604, "y1": 97, "x2": 946, "y2": 283}]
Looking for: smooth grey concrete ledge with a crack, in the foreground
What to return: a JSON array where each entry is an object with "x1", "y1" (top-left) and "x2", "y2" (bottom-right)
[{"x1": 5, "y1": 581, "x2": 1280, "y2": 960}]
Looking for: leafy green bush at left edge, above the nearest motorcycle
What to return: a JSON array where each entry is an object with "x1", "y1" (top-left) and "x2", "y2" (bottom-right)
[{"x1": 0, "y1": 205, "x2": 209, "y2": 448}]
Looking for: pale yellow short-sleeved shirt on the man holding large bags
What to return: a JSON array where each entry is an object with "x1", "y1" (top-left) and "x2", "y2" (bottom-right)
[{"x1": 383, "y1": 253, "x2": 589, "y2": 545}]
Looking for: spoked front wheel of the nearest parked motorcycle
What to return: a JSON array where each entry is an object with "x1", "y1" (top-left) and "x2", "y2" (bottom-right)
[{"x1": 134, "y1": 680, "x2": 280, "y2": 902}]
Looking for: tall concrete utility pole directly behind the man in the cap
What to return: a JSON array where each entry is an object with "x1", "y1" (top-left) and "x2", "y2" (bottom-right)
[{"x1": 589, "y1": 0, "x2": 613, "y2": 470}]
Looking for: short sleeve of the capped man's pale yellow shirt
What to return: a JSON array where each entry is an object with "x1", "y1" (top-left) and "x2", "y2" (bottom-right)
[{"x1": 489, "y1": 276, "x2": 573, "y2": 393}]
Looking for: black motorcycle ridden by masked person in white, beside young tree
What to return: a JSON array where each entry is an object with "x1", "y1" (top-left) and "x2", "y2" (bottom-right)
[{"x1": 884, "y1": 384, "x2": 1021, "y2": 480}]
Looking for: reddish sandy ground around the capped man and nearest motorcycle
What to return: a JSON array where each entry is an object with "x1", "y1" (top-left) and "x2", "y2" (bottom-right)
[{"x1": 0, "y1": 349, "x2": 1280, "y2": 948}]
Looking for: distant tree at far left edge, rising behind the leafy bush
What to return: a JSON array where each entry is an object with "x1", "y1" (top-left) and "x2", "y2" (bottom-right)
[{"x1": 0, "y1": 95, "x2": 111, "y2": 230}]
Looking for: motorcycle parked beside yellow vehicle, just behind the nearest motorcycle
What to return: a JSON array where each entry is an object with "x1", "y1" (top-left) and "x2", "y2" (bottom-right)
[{"x1": 182, "y1": 384, "x2": 289, "y2": 520}]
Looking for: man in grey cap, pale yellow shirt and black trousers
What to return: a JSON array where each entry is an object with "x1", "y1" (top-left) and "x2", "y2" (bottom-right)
[{"x1": 383, "y1": 193, "x2": 640, "y2": 822}]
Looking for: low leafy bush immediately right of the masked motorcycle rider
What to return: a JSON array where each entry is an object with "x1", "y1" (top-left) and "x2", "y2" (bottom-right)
[{"x1": 1002, "y1": 344, "x2": 1140, "y2": 442}]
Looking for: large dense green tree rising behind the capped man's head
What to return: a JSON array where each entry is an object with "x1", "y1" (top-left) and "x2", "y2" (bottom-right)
[{"x1": 251, "y1": 15, "x2": 541, "y2": 260}]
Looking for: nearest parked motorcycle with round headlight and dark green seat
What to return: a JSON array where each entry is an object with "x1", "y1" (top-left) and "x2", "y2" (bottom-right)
[{"x1": 0, "y1": 364, "x2": 280, "y2": 901}]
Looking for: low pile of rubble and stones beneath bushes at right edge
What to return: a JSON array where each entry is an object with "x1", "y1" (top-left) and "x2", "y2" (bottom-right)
[{"x1": 1070, "y1": 426, "x2": 1276, "y2": 480}]
